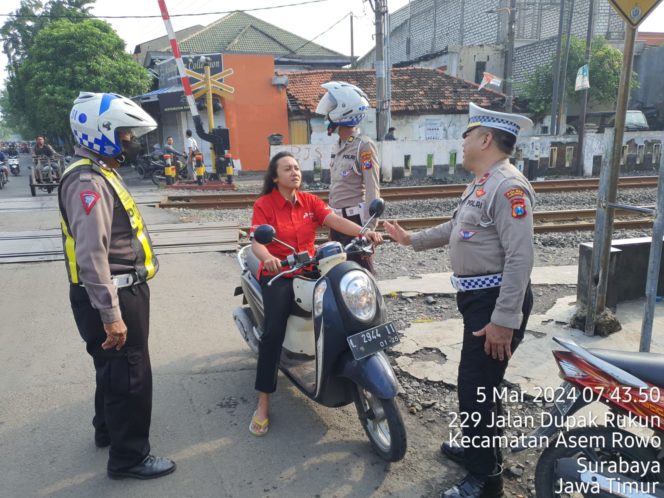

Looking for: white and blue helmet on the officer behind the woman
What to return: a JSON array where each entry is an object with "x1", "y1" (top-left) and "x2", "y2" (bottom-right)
[{"x1": 316, "y1": 81, "x2": 369, "y2": 126}]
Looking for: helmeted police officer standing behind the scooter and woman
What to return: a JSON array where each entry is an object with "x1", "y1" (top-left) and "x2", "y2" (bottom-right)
[{"x1": 316, "y1": 81, "x2": 380, "y2": 272}]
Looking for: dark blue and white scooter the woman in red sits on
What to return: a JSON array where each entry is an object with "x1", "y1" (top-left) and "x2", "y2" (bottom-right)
[{"x1": 233, "y1": 199, "x2": 406, "y2": 462}]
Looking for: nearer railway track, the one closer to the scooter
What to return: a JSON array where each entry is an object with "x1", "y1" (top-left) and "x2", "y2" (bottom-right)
[{"x1": 240, "y1": 206, "x2": 653, "y2": 234}]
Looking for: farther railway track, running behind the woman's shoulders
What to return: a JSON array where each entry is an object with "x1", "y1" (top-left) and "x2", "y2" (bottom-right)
[{"x1": 158, "y1": 176, "x2": 658, "y2": 209}]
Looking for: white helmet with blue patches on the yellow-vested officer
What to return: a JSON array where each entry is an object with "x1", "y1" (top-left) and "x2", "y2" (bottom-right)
[{"x1": 69, "y1": 92, "x2": 157, "y2": 157}]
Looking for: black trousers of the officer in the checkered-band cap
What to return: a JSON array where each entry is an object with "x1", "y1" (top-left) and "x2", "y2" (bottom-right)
[{"x1": 457, "y1": 284, "x2": 533, "y2": 476}]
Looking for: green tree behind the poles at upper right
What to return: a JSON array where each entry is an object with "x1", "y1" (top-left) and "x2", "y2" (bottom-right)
[{"x1": 516, "y1": 36, "x2": 639, "y2": 116}]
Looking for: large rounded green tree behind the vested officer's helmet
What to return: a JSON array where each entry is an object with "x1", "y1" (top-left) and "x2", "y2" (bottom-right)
[{"x1": 0, "y1": 19, "x2": 151, "y2": 147}]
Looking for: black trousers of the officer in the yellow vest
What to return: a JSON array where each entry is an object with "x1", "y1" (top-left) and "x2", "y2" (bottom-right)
[{"x1": 69, "y1": 283, "x2": 152, "y2": 471}]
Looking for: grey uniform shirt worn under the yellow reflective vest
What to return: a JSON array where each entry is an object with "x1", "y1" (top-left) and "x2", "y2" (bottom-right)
[{"x1": 60, "y1": 148, "x2": 158, "y2": 323}]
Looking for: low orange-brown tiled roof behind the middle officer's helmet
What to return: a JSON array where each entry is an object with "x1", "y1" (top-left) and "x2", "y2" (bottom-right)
[{"x1": 284, "y1": 67, "x2": 505, "y2": 114}]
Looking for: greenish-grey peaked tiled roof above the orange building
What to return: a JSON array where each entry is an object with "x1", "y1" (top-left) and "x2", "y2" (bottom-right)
[{"x1": 180, "y1": 12, "x2": 346, "y2": 58}]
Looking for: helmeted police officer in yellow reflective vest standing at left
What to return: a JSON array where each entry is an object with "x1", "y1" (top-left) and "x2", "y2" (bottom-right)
[{"x1": 58, "y1": 92, "x2": 175, "y2": 479}]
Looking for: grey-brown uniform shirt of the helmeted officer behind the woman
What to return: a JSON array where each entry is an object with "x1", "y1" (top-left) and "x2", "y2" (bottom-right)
[{"x1": 329, "y1": 128, "x2": 380, "y2": 228}]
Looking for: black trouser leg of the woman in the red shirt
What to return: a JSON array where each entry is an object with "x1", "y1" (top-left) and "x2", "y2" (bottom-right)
[{"x1": 255, "y1": 277, "x2": 295, "y2": 393}]
